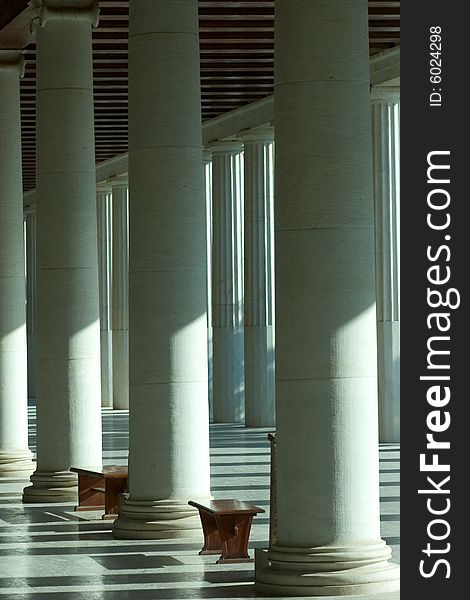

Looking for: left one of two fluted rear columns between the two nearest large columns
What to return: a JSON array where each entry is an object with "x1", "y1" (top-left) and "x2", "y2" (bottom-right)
[{"x1": 209, "y1": 141, "x2": 245, "y2": 423}]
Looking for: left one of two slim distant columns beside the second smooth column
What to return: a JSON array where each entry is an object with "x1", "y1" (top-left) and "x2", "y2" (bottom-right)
[{"x1": 96, "y1": 184, "x2": 113, "y2": 408}]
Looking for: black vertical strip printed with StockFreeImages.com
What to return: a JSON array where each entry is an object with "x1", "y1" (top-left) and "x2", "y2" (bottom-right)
[{"x1": 400, "y1": 0, "x2": 470, "y2": 600}]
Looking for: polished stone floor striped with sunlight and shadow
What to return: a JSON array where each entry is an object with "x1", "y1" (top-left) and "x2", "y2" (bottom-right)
[{"x1": 0, "y1": 408, "x2": 400, "y2": 600}]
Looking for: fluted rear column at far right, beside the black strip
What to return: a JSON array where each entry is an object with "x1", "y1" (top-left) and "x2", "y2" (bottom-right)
[{"x1": 371, "y1": 87, "x2": 400, "y2": 442}]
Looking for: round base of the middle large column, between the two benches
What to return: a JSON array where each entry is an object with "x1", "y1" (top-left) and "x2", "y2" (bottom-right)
[{"x1": 113, "y1": 495, "x2": 207, "y2": 540}]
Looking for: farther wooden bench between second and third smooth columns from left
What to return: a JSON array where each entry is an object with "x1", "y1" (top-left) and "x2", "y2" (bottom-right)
[{"x1": 70, "y1": 465, "x2": 128, "y2": 519}]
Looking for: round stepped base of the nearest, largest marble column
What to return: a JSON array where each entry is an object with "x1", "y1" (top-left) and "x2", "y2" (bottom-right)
[{"x1": 255, "y1": 542, "x2": 400, "y2": 598}]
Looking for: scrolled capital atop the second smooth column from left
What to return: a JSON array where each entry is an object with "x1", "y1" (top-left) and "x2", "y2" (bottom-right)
[{"x1": 28, "y1": 0, "x2": 100, "y2": 31}]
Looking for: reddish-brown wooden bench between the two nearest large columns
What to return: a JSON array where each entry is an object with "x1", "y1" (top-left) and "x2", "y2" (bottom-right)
[{"x1": 188, "y1": 500, "x2": 264, "y2": 564}]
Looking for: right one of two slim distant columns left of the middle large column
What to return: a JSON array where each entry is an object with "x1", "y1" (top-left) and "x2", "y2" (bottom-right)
[{"x1": 110, "y1": 177, "x2": 129, "y2": 409}]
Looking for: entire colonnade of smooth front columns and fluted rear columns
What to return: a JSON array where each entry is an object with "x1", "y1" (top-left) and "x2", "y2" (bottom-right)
[{"x1": 0, "y1": 0, "x2": 399, "y2": 596}]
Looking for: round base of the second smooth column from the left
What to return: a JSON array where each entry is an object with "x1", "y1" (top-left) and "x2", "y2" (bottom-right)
[{"x1": 23, "y1": 471, "x2": 78, "y2": 504}]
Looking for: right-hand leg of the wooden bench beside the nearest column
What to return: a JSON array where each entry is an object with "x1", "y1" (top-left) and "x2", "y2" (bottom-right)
[{"x1": 215, "y1": 515, "x2": 253, "y2": 564}]
